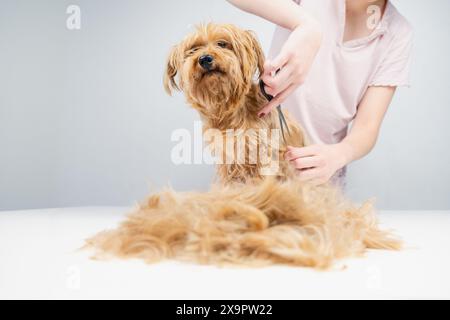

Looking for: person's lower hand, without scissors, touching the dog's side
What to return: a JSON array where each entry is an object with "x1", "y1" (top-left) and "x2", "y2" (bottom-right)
[{"x1": 285, "y1": 144, "x2": 347, "y2": 185}]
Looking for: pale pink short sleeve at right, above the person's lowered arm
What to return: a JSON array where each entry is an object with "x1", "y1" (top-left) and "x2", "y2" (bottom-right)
[{"x1": 369, "y1": 25, "x2": 413, "y2": 87}]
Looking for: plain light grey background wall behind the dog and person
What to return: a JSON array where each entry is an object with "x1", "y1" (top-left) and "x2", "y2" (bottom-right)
[{"x1": 0, "y1": 0, "x2": 450, "y2": 210}]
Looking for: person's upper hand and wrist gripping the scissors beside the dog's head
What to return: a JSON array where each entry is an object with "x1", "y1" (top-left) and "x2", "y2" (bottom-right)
[{"x1": 259, "y1": 23, "x2": 322, "y2": 117}]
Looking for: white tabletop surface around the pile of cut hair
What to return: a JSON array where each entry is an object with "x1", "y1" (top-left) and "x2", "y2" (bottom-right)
[{"x1": 0, "y1": 207, "x2": 450, "y2": 299}]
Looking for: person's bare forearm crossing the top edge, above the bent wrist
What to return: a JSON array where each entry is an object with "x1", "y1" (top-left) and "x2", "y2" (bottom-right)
[{"x1": 227, "y1": 0, "x2": 318, "y2": 30}]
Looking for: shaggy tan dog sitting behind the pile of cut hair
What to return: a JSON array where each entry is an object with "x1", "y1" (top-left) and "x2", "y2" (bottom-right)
[{"x1": 164, "y1": 24, "x2": 306, "y2": 183}]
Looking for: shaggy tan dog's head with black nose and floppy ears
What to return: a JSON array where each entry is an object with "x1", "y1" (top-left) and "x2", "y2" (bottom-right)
[{"x1": 164, "y1": 23, "x2": 264, "y2": 114}]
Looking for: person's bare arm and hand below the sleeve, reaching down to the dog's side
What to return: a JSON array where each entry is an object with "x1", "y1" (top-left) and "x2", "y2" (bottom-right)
[{"x1": 286, "y1": 87, "x2": 396, "y2": 184}]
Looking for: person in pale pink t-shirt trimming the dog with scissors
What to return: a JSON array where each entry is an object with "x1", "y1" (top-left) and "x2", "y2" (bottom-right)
[{"x1": 228, "y1": 0, "x2": 413, "y2": 185}]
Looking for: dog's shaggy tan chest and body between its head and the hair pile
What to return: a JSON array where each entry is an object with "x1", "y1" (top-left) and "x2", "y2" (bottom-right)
[{"x1": 203, "y1": 85, "x2": 306, "y2": 183}]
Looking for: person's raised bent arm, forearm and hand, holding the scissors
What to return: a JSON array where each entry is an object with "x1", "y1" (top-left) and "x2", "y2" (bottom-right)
[{"x1": 227, "y1": 0, "x2": 322, "y2": 116}]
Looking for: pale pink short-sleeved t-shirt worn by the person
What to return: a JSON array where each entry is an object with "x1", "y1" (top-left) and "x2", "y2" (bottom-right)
[{"x1": 269, "y1": 0, "x2": 412, "y2": 144}]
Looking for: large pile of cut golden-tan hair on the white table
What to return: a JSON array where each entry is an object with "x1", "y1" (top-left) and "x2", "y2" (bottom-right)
[{"x1": 88, "y1": 178, "x2": 400, "y2": 268}]
